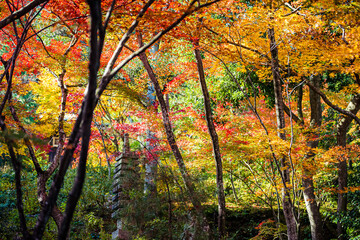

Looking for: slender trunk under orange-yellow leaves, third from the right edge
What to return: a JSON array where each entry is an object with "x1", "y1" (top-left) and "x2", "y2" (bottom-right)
[{"x1": 268, "y1": 28, "x2": 299, "y2": 240}]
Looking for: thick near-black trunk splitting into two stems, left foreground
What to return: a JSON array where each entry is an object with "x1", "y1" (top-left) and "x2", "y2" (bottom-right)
[{"x1": 34, "y1": 0, "x2": 105, "y2": 236}]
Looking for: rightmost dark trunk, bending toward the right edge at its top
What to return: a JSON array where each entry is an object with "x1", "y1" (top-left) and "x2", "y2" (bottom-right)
[{"x1": 336, "y1": 94, "x2": 360, "y2": 239}]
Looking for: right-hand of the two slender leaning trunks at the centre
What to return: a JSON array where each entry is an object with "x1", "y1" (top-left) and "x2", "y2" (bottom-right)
[{"x1": 194, "y1": 42, "x2": 226, "y2": 239}]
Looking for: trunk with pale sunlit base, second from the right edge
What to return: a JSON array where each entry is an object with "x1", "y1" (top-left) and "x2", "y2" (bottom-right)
[{"x1": 302, "y1": 76, "x2": 324, "y2": 240}]
